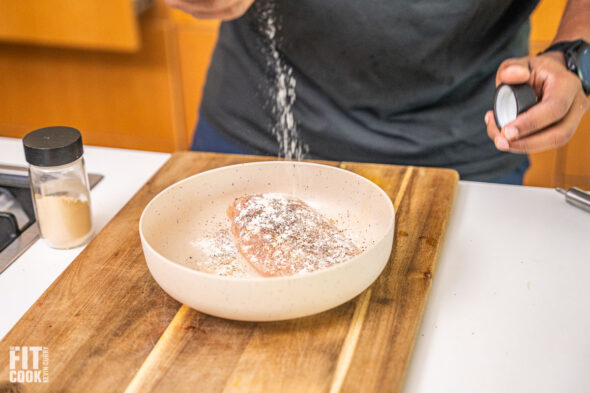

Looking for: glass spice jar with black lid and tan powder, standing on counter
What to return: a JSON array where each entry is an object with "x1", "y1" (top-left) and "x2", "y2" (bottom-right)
[{"x1": 23, "y1": 127, "x2": 92, "y2": 249}]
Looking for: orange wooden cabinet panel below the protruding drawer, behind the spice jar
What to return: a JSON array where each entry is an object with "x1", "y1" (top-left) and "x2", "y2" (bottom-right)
[{"x1": 0, "y1": 3, "x2": 187, "y2": 152}]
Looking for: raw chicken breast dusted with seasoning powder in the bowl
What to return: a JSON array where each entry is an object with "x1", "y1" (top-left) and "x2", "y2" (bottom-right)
[{"x1": 227, "y1": 193, "x2": 360, "y2": 276}]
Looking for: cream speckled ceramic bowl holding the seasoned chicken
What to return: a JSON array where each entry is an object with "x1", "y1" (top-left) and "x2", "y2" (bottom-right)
[{"x1": 139, "y1": 161, "x2": 394, "y2": 321}]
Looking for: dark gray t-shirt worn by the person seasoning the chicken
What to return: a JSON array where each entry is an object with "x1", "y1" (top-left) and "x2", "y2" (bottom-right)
[{"x1": 201, "y1": 0, "x2": 538, "y2": 180}]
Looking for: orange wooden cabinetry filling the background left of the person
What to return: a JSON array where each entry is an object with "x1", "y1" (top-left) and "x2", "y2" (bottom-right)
[{"x1": 0, "y1": 0, "x2": 219, "y2": 152}]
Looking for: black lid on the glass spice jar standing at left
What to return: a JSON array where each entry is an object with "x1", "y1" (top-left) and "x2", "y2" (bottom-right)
[{"x1": 23, "y1": 126, "x2": 84, "y2": 167}]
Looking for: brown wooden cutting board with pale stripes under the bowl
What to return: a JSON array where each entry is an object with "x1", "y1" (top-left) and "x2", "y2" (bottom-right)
[{"x1": 0, "y1": 152, "x2": 458, "y2": 392}]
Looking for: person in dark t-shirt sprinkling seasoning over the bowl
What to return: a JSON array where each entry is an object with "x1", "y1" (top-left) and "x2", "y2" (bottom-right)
[{"x1": 167, "y1": 0, "x2": 590, "y2": 184}]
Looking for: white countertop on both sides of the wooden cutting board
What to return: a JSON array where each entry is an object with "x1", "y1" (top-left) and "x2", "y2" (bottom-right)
[{"x1": 0, "y1": 138, "x2": 590, "y2": 393}]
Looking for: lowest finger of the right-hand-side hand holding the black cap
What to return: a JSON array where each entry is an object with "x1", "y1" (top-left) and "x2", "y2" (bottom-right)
[{"x1": 498, "y1": 93, "x2": 590, "y2": 153}]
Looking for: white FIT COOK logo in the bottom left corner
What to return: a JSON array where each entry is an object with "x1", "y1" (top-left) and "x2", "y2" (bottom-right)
[{"x1": 8, "y1": 347, "x2": 49, "y2": 383}]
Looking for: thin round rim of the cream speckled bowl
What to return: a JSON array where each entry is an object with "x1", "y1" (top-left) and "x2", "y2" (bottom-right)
[{"x1": 139, "y1": 160, "x2": 395, "y2": 283}]
